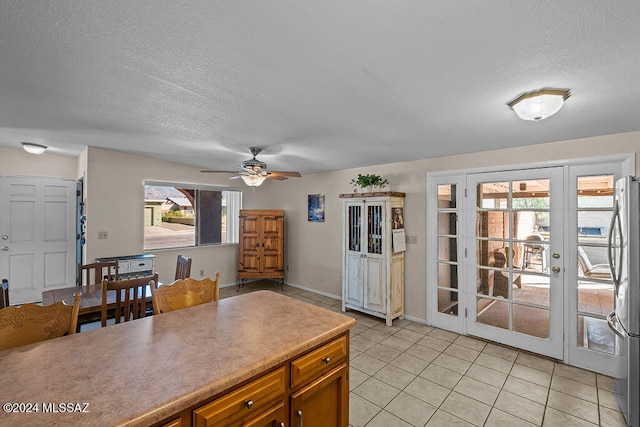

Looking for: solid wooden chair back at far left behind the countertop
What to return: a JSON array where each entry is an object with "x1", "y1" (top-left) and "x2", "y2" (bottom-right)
[{"x1": 0, "y1": 292, "x2": 80, "y2": 350}]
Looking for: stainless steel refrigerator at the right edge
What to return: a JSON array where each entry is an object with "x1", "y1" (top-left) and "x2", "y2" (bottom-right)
[{"x1": 608, "y1": 176, "x2": 640, "y2": 427}]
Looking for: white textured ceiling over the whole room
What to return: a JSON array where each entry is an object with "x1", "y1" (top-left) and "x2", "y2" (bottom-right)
[{"x1": 0, "y1": 0, "x2": 640, "y2": 173}]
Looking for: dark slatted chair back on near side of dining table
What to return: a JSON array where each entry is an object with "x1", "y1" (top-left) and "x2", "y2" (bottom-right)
[{"x1": 100, "y1": 273, "x2": 158, "y2": 327}]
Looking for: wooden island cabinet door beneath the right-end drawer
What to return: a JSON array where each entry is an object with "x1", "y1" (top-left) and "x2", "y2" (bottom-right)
[{"x1": 290, "y1": 365, "x2": 349, "y2": 427}]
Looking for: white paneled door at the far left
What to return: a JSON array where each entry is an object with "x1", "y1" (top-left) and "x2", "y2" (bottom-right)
[{"x1": 0, "y1": 176, "x2": 76, "y2": 305}]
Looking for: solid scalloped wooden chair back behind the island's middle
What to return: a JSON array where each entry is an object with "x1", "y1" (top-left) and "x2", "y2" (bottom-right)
[{"x1": 151, "y1": 271, "x2": 220, "y2": 314}]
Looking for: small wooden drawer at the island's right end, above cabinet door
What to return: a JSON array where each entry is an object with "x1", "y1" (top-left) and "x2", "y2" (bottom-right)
[{"x1": 291, "y1": 337, "x2": 347, "y2": 387}]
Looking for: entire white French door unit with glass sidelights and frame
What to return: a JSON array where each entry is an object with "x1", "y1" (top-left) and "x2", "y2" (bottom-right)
[{"x1": 426, "y1": 156, "x2": 635, "y2": 376}]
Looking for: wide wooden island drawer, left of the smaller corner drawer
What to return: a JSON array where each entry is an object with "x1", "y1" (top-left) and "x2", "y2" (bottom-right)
[{"x1": 193, "y1": 367, "x2": 285, "y2": 427}]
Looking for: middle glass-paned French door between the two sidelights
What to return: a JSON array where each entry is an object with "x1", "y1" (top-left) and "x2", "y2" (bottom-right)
[{"x1": 467, "y1": 168, "x2": 563, "y2": 358}]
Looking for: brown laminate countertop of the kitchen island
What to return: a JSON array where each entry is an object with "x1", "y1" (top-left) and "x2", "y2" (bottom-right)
[{"x1": 0, "y1": 291, "x2": 355, "y2": 426}]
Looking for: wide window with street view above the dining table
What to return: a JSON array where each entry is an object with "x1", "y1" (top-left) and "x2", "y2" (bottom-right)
[{"x1": 144, "y1": 181, "x2": 242, "y2": 250}]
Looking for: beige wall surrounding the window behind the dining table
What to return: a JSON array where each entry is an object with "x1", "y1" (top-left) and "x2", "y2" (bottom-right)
[{"x1": 85, "y1": 147, "x2": 238, "y2": 285}]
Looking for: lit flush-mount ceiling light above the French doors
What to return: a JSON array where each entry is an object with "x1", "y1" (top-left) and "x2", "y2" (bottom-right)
[{"x1": 507, "y1": 87, "x2": 571, "y2": 122}]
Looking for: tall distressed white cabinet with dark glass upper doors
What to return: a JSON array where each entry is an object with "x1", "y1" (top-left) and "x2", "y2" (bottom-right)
[{"x1": 340, "y1": 192, "x2": 405, "y2": 326}]
